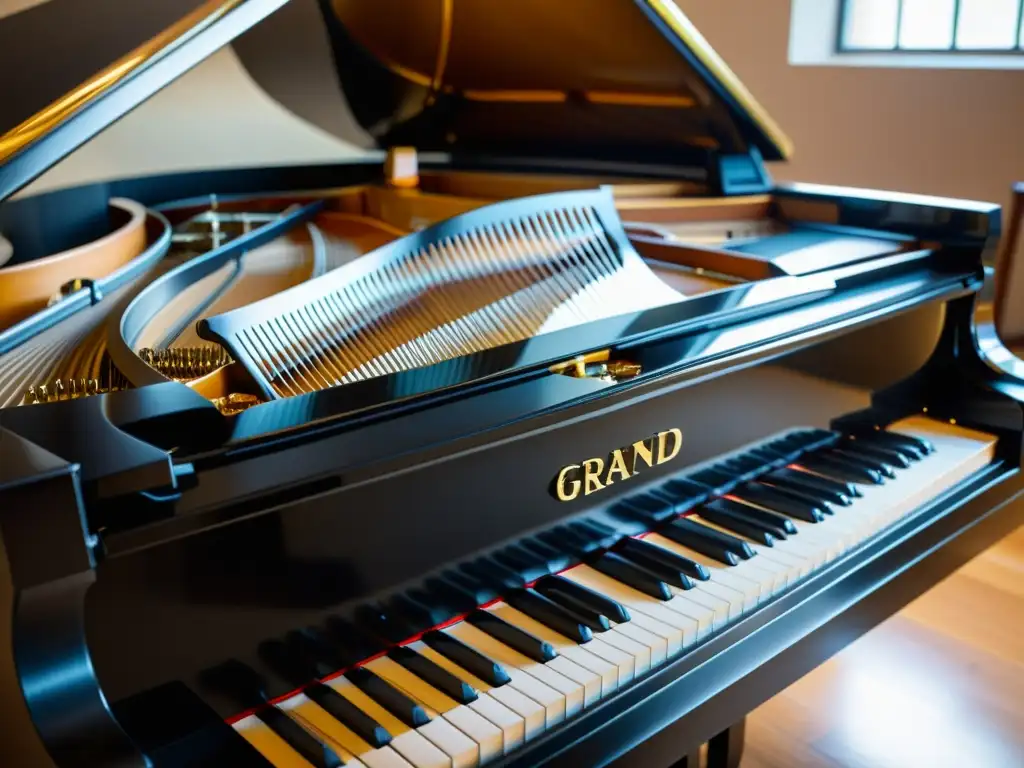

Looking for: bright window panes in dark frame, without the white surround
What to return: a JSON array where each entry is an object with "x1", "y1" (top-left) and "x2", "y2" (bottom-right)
[{"x1": 838, "y1": 0, "x2": 1024, "y2": 54}]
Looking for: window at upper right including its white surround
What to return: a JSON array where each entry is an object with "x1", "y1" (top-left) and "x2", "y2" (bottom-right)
[{"x1": 790, "y1": 0, "x2": 1024, "y2": 70}]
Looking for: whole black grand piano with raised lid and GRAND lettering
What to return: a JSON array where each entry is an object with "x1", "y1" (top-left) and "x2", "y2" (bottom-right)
[{"x1": 0, "y1": 0, "x2": 1024, "y2": 768}]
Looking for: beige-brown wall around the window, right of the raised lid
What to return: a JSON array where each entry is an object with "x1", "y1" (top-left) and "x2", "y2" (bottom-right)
[{"x1": 677, "y1": 0, "x2": 1024, "y2": 210}]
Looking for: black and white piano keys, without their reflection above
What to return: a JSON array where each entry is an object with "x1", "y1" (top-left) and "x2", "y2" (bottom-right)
[{"x1": 197, "y1": 417, "x2": 995, "y2": 768}]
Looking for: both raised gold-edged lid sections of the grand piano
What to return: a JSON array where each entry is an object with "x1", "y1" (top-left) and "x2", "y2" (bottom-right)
[{"x1": 0, "y1": 0, "x2": 791, "y2": 200}]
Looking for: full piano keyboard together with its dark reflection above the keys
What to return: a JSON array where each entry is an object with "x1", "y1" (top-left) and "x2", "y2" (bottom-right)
[{"x1": 207, "y1": 417, "x2": 995, "y2": 768}]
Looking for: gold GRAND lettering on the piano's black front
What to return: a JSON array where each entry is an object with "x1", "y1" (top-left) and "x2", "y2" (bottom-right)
[{"x1": 551, "y1": 427, "x2": 683, "y2": 502}]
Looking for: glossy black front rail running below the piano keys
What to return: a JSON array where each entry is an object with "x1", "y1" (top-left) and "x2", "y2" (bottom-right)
[{"x1": 492, "y1": 459, "x2": 1024, "y2": 768}]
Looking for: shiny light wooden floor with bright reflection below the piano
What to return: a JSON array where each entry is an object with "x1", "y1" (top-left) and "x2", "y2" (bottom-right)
[{"x1": 740, "y1": 527, "x2": 1024, "y2": 768}]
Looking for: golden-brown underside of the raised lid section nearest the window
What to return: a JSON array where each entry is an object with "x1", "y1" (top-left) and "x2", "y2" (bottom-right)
[{"x1": 319, "y1": 0, "x2": 791, "y2": 166}]
